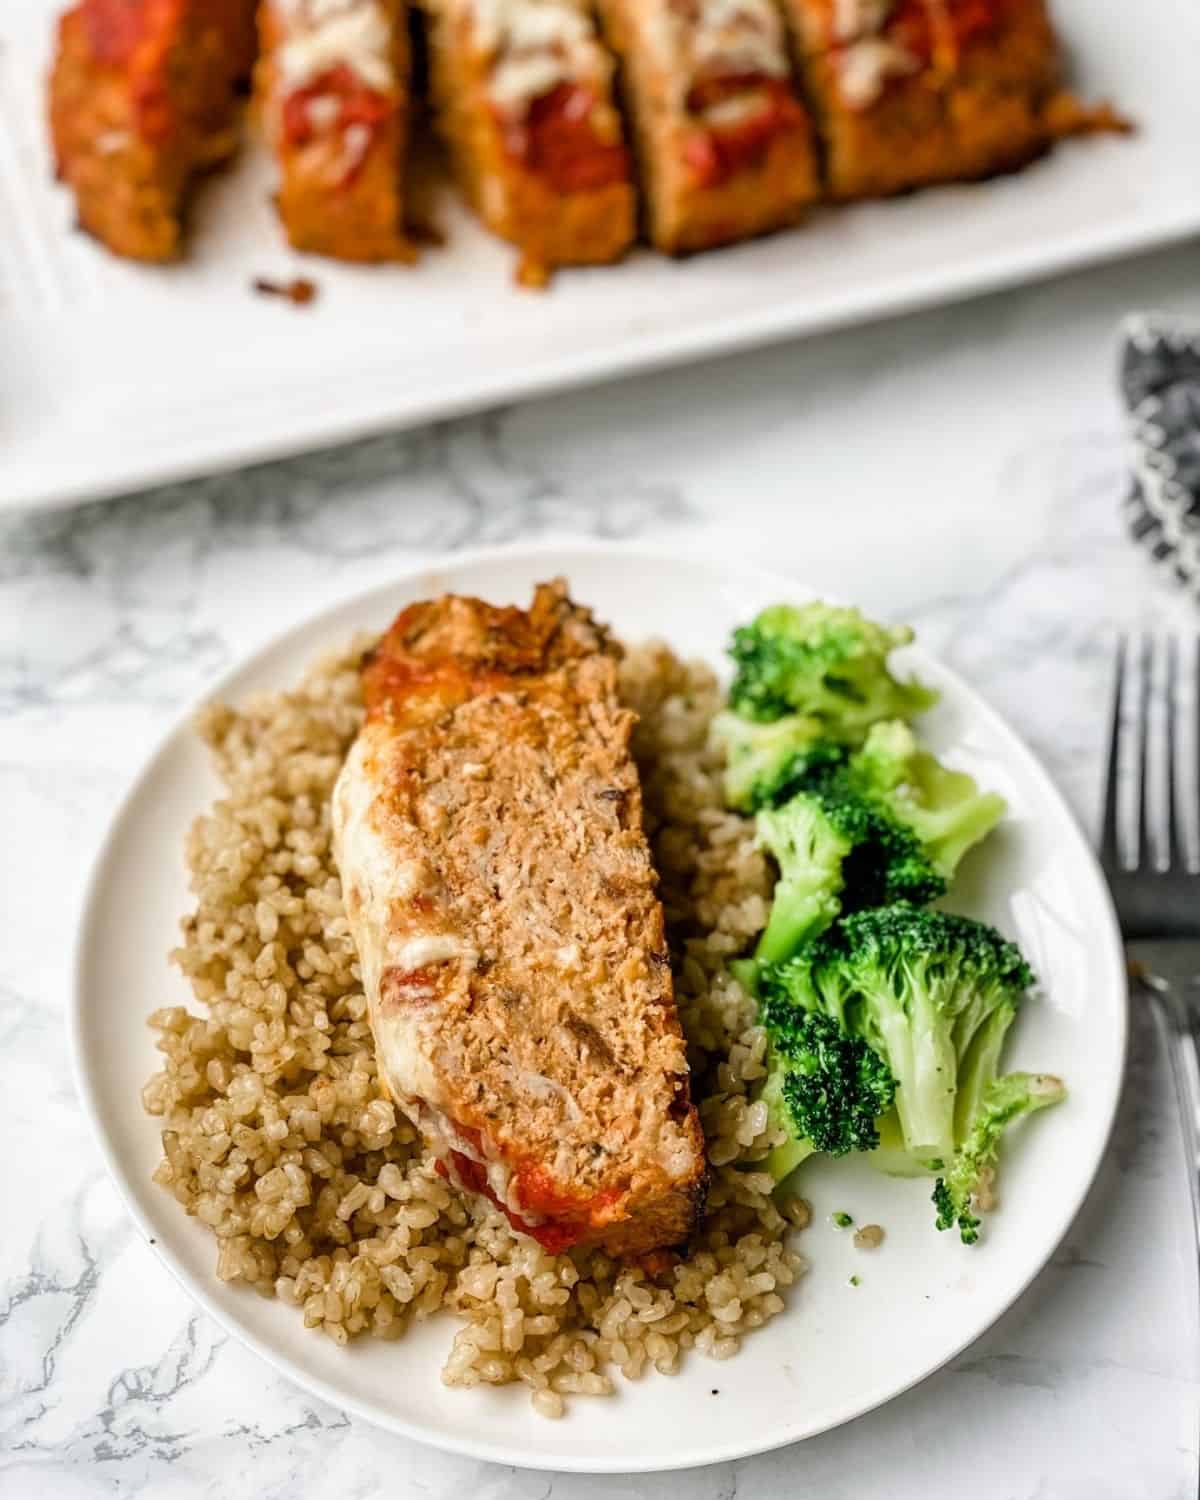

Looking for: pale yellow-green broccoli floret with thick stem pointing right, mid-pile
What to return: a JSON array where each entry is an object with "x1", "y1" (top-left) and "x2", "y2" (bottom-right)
[{"x1": 849, "y1": 720, "x2": 1005, "y2": 881}]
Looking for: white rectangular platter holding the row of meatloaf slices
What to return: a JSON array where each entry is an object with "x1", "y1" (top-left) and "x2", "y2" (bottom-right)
[{"x1": 0, "y1": 0, "x2": 1200, "y2": 509}]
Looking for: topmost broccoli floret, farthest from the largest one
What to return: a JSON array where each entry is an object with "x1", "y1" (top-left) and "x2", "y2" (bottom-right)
[{"x1": 729, "y1": 602, "x2": 938, "y2": 732}]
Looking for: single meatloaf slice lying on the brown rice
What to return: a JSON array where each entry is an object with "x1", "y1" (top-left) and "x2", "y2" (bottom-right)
[{"x1": 333, "y1": 584, "x2": 705, "y2": 1254}]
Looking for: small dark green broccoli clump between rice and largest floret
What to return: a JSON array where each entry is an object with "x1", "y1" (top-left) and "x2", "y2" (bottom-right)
[{"x1": 761, "y1": 996, "x2": 896, "y2": 1182}]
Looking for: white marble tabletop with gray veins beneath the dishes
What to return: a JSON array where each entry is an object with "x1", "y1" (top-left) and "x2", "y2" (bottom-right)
[{"x1": 0, "y1": 246, "x2": 1200, "y2": 1500}]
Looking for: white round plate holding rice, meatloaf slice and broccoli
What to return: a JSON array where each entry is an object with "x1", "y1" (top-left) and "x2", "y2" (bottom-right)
[{"x1": 72, "y1": 545, "x2": 1127, "y2": 1472}]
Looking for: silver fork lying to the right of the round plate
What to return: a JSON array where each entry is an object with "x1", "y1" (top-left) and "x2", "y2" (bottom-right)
[{"x1": 1100, "y1": 636, "x2": 1200, "y2": 1244}]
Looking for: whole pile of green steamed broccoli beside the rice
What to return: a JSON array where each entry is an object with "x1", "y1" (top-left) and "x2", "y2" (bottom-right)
[{"x1": 723, "y1": 603, "x2": 1065, "y2": 1244}]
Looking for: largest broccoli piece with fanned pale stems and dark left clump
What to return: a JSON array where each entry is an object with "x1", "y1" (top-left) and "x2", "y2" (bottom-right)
[{"x1": 756, "y1": 903, "x2": 1067, "y2": 1245}]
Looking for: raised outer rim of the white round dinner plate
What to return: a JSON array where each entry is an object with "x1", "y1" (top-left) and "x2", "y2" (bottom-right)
[{"x1": 66, "y1": 536, "x2": 1130, "y2": 1475}]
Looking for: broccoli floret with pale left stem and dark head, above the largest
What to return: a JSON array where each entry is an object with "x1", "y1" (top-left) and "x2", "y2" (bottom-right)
[{"x1": 755, "y1": 786, "x2": 947, "y2": 963}]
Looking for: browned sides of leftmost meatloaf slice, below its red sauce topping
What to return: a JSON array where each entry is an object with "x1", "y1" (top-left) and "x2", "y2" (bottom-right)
[{"x1": 50, "y1": 0, "x2": 254, "y2": 261}]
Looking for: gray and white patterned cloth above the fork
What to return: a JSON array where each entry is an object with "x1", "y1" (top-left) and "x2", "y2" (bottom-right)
[{"x1": 1121, "y1": 318, "x2": 1200, "y2": 596}]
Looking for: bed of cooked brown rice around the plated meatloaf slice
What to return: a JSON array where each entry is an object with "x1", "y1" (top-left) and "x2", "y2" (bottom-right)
[{"x1": 144, "y1": 641, "x2": 803, "y2": 1416}]
